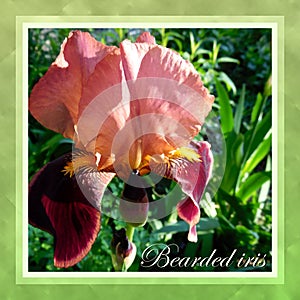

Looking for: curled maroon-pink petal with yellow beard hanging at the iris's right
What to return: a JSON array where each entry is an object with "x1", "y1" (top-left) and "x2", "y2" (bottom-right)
[{"x1": 150, "y1": 142, "x2": 213, "y2": 242}]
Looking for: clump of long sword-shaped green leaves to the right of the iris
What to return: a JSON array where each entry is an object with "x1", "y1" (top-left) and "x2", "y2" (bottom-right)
[{"x1": 215, "y1": 75, "x2": 272, "y2": 262}]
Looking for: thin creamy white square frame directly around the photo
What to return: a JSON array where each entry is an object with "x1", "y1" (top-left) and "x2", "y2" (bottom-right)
[{"x1": 18, "y1": 17, "x2": 279, "y2": 282}]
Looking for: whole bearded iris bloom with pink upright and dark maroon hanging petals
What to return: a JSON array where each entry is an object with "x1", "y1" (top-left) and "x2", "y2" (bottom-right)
[{"x1": 29, "y1": 31, "x2": 214, "y2": 268}]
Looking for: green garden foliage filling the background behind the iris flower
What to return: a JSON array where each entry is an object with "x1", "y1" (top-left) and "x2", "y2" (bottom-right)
[{"x1": 28, "y1": 29, "x2": 272, "y2": 271}]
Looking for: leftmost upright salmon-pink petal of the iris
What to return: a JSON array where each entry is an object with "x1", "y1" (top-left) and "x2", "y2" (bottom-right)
[{"x1": 29, "y1": 31, "x2": 115, "y2": 138}]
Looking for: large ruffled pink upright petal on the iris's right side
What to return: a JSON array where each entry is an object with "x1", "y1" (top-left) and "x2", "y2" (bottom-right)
[{"x1": 120, "y1": 33, "x2": 214, "y2": 162}]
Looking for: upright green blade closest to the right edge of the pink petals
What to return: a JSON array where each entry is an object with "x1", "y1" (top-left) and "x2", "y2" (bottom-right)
[{"x1": 216, "y1": 79, "x2": 234, "y2": 136}]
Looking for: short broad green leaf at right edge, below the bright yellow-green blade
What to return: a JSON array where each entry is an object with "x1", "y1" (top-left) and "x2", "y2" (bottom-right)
[{"x1": 236, "y1": 171, "x2": 271, "y2": 202}]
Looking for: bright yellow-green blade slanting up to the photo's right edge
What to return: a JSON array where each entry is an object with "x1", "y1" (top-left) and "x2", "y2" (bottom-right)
[{"x1": 242, "y1": 134, "x2": 272, "y2": 176}]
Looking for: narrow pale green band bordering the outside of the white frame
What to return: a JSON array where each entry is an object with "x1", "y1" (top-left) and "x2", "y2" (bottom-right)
[{"x1": 16, "y1": 16, "x2": 284, "y2": 285}]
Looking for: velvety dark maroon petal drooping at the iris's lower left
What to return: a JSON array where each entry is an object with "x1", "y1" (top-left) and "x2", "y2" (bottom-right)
[{"x1": 28, "y1": 155, "x2": 100, "y2": 268}]
